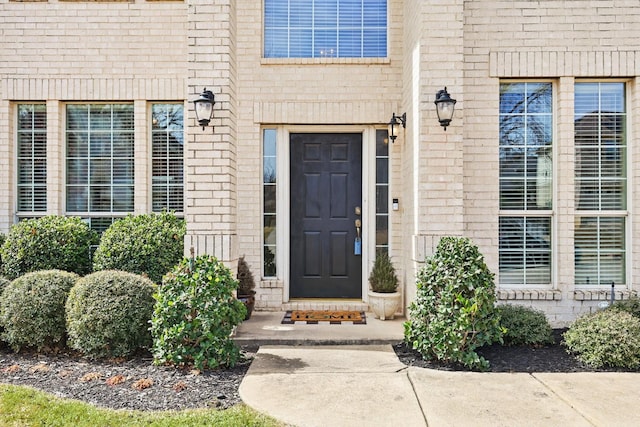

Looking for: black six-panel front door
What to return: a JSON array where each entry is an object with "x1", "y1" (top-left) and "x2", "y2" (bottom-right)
[{"x1": 289, "y1": 133, "x2": 362, "y2": 298}]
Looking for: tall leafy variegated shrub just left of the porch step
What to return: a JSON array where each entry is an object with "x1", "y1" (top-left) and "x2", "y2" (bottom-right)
[{"x1": 151, "y1": 255, "x2": 246, "y2": 369}]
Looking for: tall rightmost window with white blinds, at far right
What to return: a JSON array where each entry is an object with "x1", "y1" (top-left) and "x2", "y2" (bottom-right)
[{"x1": 574, "y1": 82, "x2": 627, "y2": 285}]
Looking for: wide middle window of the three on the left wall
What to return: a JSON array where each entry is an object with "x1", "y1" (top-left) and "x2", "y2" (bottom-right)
[{"x1": 66, "y1": 103, "x2": 134, "y2": 216}]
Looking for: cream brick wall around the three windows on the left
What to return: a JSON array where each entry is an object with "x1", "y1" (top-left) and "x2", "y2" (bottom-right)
[{"x1": 0, "y1": 0, "x2": 187, "y2": 232}]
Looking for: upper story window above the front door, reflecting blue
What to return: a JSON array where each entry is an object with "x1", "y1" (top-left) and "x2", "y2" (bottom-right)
[{"x1": 264, "y1": 0, "x2": 387, "y2": 58}]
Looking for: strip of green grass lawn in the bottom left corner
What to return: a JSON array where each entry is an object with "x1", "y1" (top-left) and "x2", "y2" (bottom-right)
[{"x1": 0, "y1": 384, "x2": 282, "y2": 427}]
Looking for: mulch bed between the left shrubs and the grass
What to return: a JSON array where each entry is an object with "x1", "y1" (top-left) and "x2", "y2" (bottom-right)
[{"x1": 0, "y1": 344, "x2": 252, "y2": 411}]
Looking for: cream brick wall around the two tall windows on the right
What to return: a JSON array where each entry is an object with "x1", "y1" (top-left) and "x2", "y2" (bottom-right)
[{"x1": 462, "y1": 1, "x2": 640, "y2": 325}]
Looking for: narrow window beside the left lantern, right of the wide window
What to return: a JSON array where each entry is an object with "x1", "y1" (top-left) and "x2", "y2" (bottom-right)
[{"x1": 151, "y1": 103, "x2": 184, "y2": 213}]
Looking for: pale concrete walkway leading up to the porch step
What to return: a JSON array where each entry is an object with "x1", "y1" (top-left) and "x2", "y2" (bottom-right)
[{"x1": 236, "y1": 314, "x2": 640, "y2": 427}]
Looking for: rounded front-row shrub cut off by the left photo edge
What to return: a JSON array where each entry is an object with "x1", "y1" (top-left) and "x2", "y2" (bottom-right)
[{"x1": 0, "y1": 270, "x2": 78, "y2": 351}]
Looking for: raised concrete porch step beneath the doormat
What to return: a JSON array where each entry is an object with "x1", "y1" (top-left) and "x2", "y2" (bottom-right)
[{"x1": 233, "y1": 308, "x2": 404, "y2": 350}]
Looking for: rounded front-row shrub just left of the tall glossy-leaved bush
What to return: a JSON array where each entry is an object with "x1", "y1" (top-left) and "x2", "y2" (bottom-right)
[{"x1": 66, "y1": 270, "x2": 156, "y2": 358}]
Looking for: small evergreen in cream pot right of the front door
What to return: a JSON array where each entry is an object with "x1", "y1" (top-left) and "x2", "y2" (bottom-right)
[{"x1": 368, "y1": 250, "x2": 401, "y2": 320}]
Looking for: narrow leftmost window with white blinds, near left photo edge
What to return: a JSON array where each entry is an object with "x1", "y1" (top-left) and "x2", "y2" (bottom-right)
[{"x1": 17, "y1": 103, "x2": 47, "y2": 215}]
